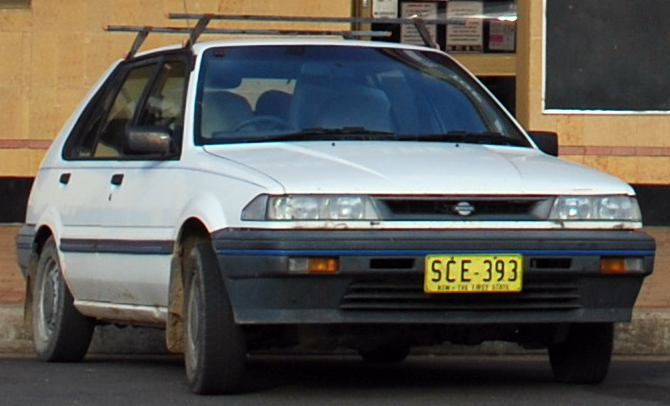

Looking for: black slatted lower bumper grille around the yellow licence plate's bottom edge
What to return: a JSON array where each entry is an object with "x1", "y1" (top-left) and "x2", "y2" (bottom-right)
[{"x1": 340, "y1": 276, "x2": 581, "y2": 312}]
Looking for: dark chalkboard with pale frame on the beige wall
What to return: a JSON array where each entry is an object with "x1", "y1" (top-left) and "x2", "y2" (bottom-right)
[{"x1": 545, "y1": 0, "x2": 670, "y2": 111}]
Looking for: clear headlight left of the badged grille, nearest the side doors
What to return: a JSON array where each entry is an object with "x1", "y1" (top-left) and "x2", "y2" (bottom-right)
[{"x1": 242, "y1": 195, "x2": 379, "y2": 221}]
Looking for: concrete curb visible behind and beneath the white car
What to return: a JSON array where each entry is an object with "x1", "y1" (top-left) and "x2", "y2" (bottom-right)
[{"x1": 0, "y1": 305, "x2": 670, "y2": 356}]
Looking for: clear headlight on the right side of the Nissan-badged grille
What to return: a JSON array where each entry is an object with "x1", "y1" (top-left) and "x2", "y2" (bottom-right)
[{"x1": 549, "y1": 195, "x2": 642, "y2": 221}]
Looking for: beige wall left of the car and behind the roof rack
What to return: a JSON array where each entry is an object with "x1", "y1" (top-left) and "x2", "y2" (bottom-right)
[{"x1": 0, "y1": 0, "x2": 352, "y2": 176}]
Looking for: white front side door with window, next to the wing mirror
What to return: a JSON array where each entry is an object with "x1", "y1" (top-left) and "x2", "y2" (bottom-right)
[{"x1": 93, "y1": 54, "x2": 190, "y2": 307}]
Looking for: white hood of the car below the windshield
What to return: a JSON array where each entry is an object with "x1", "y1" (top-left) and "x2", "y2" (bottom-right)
[{"x1": 205, "y1": 141, "x2": 633, "y2": 195}]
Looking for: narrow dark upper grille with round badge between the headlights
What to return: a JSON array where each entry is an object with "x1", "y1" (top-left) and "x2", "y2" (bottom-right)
[{"x1": 376, "y1": 196, "x2": 553, "y2": 221}]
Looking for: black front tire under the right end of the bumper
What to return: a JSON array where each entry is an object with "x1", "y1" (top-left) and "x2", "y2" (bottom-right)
[{"x1": 549, "y1": 323, "x2": 614, "y2": 384}]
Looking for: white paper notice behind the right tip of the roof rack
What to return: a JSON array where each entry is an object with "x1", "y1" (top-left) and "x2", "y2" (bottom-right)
[{"x1": 447, "y1": 1, "x2": 484, "y2": 52}]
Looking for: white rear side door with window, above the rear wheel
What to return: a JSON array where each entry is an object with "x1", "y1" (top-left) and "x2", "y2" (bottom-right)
[{"x1": 57, "y1": 58, "x2": 172, "y2": 303}]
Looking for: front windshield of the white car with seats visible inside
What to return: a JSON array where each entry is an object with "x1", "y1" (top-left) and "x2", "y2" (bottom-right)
[{"x1": 196, "y1": 45, "x2": 529, "y2": 146}]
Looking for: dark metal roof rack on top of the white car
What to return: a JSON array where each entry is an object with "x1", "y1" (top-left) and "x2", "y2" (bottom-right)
[{"x1": 103, "y1": 13, "x2": 464, "y2": 59}]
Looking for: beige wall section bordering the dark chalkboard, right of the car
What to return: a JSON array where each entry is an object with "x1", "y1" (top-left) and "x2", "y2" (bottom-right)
[{"x1": 517, "y1": 0, "x2": 670, "y2": 184}]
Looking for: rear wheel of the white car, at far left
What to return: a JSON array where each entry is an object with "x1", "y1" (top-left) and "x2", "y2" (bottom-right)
[{"x1": 32, "y1": 237, "x2": 95, "y2": 362}]
